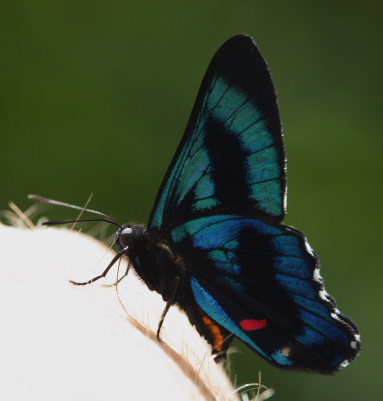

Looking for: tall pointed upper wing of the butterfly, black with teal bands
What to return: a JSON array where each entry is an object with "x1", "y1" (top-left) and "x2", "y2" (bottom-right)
[{"x1": 149, "y1": 35, "x2": 286, "y2": 231}]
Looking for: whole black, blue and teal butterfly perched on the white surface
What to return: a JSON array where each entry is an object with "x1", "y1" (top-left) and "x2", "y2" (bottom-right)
[{"x1": 33, "y1": 35, "x2": 360, "y2": 374}]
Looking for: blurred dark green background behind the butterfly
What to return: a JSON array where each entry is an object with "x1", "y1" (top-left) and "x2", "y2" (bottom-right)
[{"x1": 0, "y1": 0, "x2": 383, "y2": 401}]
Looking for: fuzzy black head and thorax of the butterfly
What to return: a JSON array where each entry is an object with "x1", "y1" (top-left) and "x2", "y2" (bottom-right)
[{"x1": 116, "y1": 225, "x2": 186, "y2": 301}]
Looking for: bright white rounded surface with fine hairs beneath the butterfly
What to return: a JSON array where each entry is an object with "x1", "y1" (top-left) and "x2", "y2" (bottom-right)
[{"x1": 0, "y1": 225, "x2": 237, "y2": 401}]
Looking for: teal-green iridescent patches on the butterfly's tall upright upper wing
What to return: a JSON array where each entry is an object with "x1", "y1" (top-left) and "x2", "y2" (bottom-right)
[{"x1": 151, "y1": 77, "x2": 284, "y2": 228}]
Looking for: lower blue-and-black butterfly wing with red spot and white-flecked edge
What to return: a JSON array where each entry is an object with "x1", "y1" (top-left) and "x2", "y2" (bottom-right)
[{"x1": 170, "y1": 215, "x2": 360, "y2": 373}]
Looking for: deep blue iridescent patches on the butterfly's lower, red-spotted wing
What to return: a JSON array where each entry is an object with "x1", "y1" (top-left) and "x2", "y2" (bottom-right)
[{"x1": 171, "y1": 215, "x2": 354, "y2": 366}]
